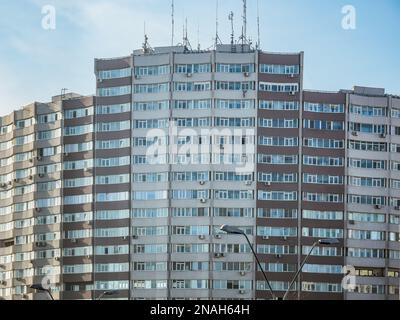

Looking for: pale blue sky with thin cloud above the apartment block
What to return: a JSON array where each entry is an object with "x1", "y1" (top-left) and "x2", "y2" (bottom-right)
[{"x1": 0, "y1": 0, "x2": 400, "y2": 114}]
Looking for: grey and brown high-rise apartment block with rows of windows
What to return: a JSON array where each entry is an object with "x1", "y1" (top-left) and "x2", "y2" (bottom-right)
[{"x1": 0, "y1": 45, "x2": 400, "y2": 300}]
